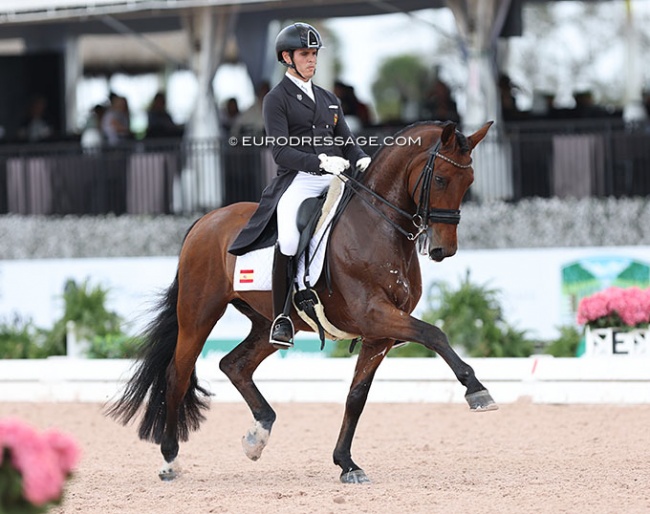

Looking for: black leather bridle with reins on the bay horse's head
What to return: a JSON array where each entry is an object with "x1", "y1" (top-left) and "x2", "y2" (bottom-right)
[{"x1": 343, "y1": 139, "x2": 472, "y2": 254}]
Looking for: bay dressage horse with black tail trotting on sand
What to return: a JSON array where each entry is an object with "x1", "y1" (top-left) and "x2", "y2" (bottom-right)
[{"x1": 108, "y1": 118, "x2": 497, "y2": 483}]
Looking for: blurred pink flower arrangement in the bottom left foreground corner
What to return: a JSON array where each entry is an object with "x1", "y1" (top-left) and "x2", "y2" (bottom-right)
[{"x1": 0, "y1": 419, "x2": 79, "y2": 514}]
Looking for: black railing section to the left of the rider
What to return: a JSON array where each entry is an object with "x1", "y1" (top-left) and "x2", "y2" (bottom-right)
[{"x1": 0, "y1": 140, "x2": 275, "y2": 215}]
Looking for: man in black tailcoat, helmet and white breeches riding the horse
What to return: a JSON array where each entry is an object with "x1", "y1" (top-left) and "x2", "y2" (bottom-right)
[{"x1": 230, "y1": 23, "x2": 370, "y2": 349}]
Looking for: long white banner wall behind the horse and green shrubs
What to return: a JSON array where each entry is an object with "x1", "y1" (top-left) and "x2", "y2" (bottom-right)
[{"x1": 0, "y1": 246, "x2": 650, "y2": 340}]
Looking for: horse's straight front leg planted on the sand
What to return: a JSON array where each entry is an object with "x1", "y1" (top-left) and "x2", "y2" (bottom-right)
[{"x1": 334, "y1": 340, "x2": 394, "y2": 484}]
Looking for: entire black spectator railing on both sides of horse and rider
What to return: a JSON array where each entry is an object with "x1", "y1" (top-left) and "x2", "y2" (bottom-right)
[{"x1": 0, "y1": 120, "x2": 650, "y2": 215}]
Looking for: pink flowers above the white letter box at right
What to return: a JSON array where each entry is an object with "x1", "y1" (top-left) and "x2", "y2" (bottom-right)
[{"x1": 577, "y1": 287, "x2": 650, "y2": 328}]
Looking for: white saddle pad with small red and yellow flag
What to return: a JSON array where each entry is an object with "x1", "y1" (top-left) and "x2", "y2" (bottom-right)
[{"x1": 233, "y1": 177, "x2": 345, "y2": 291}]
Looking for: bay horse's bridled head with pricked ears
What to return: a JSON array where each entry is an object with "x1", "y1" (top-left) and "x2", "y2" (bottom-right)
[{"x1": 407, "y1": 122, "x2": 492, "y2": 262}]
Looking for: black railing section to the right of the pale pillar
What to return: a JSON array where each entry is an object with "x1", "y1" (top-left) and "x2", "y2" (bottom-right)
[{"x1": 507, "y1": 118, "x2": 650, "y2": 200}]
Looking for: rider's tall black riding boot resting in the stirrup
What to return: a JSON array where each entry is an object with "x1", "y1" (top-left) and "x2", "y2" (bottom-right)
[{"x1": 269, "y1": 245, "x2": 293, "y2": 350}]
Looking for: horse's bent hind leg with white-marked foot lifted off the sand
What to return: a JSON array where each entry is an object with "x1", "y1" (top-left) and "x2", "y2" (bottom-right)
[{"x1": 219, "y1": 301, "x2": 276, "y2": 460}]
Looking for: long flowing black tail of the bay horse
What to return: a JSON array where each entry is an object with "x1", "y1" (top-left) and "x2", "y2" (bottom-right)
[{"x1": 107, "y1": 272, "x2": 210, "y2": 443}]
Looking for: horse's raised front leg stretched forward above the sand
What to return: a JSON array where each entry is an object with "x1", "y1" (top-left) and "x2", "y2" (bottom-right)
[{"x1": 368, "y1": 306, "x2": 498, "y2": 412}]
